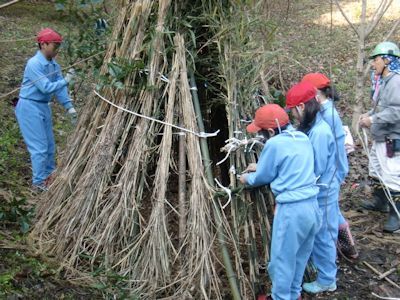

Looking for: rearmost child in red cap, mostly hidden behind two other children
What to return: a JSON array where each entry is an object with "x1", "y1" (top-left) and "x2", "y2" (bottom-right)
[{"x1": 301, "y1": 73, "x2": 358, "y2": 258}]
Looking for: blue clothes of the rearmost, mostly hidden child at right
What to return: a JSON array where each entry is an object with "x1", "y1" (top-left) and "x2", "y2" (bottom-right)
[{"x1": 321, "y1": 100, "x2": 349, "y2": 225}]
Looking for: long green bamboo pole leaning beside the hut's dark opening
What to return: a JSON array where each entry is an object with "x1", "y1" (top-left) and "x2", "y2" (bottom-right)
[{"x1": 189, "y1": 71, "x2": 241, "y2": 300}]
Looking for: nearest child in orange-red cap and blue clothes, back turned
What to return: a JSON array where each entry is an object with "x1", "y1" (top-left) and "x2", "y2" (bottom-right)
[{"x1": 240, "y1": 104, "x2": 321, "y2": 300}]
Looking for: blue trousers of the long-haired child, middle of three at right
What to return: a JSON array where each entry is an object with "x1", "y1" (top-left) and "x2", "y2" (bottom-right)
[{"x1": 311, "y1": 184, "x2": 341, "y2": 286}]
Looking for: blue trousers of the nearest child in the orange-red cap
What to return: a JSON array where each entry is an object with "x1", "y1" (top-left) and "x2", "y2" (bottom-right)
[{"x1": 268, "y1": 197, "x2": 321, "y2": 300}]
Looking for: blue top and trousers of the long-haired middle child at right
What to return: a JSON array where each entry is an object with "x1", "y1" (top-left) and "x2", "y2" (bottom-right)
[{"x1": 308, "y1": 113, "x2": 340, "y2": 286}]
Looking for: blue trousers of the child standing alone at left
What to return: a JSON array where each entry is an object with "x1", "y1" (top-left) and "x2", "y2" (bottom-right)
[{"x1": 15, "y1": 99, "x2": 55, "y2": 185}]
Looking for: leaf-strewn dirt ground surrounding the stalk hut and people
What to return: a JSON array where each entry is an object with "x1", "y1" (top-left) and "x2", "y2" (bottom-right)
[{"x1": 0, "y1": 0, "x2": 400, "y2": 299}]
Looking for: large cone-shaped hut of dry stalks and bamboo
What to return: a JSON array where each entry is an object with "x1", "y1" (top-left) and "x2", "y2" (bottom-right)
[{"x1": 31, "y1": 0, "x2": 278, "y2": 299}]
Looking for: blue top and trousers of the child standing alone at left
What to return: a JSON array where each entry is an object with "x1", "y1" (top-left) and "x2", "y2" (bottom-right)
[{"x1": 15, "y1": 51, "x2": 73, "y2": 185}]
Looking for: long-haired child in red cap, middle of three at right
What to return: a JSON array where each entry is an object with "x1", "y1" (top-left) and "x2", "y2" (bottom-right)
[{"x1": 286, "y1": 82, "x2": 340, "y2": 293}]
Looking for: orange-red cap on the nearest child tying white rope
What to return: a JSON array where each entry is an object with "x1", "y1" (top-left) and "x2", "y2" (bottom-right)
[{"x1": 246, "y1": 104, "x2": 289, "y2": 133}]
